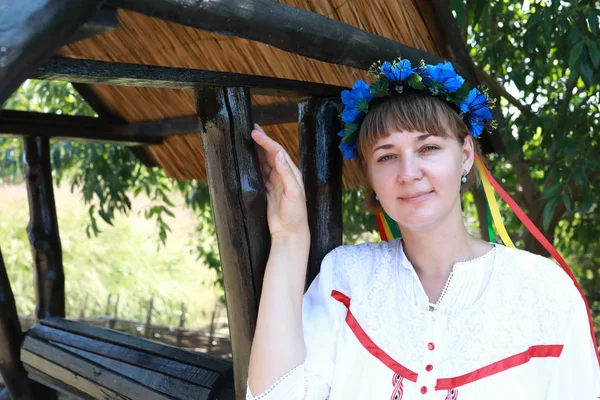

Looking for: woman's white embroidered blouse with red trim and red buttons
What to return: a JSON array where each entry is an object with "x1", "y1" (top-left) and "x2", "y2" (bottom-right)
[{"x1": 246, "y1": 240, "x2": 600, "y2": 400}]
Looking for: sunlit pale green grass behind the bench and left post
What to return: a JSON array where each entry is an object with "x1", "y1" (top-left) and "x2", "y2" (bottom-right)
[{"x1": 0, "y1": 185, "x2": 220, "y2": 328}]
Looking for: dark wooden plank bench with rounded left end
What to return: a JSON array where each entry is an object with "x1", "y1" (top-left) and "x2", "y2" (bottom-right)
[{"x1": 21, "y1": 318, "x2": 234, "y2": 400}]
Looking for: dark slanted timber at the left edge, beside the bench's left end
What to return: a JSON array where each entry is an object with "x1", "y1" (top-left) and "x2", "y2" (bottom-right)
[{"x1": 0, "y1": 247, "x2": 35, "y2": 400}]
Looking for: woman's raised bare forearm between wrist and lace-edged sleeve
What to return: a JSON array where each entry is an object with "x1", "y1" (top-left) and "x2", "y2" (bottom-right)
[{"x1": 248, "y1": 229, "x2": 310, "y2": 394}]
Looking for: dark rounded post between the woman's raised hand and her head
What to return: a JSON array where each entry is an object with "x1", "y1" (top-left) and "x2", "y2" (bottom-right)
[{"x1": 298, "y1": 99, "x2": 342, "y2": 288}]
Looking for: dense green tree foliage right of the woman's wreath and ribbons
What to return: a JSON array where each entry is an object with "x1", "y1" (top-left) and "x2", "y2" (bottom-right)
[{"x1": 451, "y1": 0, "x2": 600, "y2": 313}]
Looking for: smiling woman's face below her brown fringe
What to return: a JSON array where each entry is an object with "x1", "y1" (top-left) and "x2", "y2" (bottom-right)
[{"x1": 365, "y1": 131, "x2": 473, "y2": 232}]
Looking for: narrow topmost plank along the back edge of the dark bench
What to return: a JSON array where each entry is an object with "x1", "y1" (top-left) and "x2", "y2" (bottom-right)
[{"x1": 27, "y1": 324, "x2": 222, "y2": 389}]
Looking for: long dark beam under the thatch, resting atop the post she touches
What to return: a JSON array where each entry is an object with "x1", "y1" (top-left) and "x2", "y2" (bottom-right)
[{"x1": 37, "y1": 58, "x2": 347, "y2": 97}]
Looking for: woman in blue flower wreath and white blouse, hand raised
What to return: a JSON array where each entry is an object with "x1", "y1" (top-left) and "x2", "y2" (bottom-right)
[{"x1": 247, "y1": 60, "x2": 600, "y2": 400}]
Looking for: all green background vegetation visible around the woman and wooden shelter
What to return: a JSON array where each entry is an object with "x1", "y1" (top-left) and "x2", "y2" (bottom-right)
[{"x1": 0, "y1": 0, "x2": 600, "y2": 332}]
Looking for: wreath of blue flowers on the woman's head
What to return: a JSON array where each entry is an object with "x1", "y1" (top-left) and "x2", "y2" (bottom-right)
[{"x1": 338, "y1": 58, "x2": 497, "y2": 160}]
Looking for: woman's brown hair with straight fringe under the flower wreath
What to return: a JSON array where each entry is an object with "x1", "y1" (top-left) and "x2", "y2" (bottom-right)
[{"x1": 356, "y1": 91, "x2": 480, "y2": 213}]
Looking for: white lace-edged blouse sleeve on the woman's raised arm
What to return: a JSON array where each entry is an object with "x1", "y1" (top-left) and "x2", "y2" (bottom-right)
[{"x1": 246, "y1": 250, "x2": 347, "y2": 400}]
